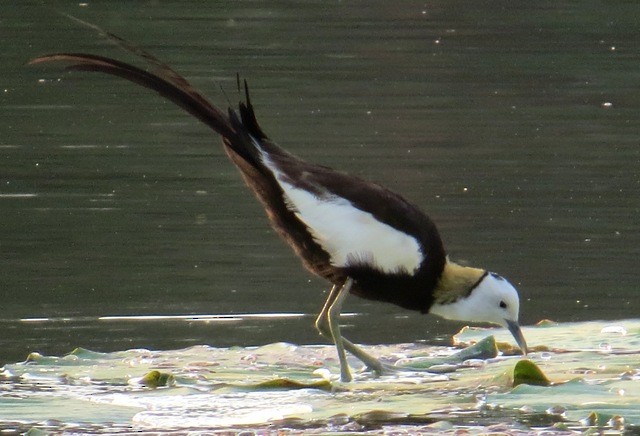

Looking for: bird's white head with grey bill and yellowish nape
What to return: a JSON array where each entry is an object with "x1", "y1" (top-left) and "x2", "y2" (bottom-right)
[{"x1": 430, "y1": 264, "x2": 527, "y2": 354}]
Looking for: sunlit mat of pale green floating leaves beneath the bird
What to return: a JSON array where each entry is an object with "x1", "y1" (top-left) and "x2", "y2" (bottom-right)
[{"x1": 0, "y1": 320, "x2": 640, "y2": 434}]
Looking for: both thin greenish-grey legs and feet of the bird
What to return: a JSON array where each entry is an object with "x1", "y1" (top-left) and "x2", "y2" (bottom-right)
[{"x1": 316, "y1": 278, "x2": 383, "y2": 381}]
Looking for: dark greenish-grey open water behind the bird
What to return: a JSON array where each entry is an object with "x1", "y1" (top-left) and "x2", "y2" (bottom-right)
[{"x1": 0, "y1": 0, "x2": 640, "y2": 362}]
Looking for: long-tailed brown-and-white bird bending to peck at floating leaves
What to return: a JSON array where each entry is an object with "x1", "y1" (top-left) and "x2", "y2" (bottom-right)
[{"x1": 29, "y1": 41, "x2": 527, "y2": 382}]
